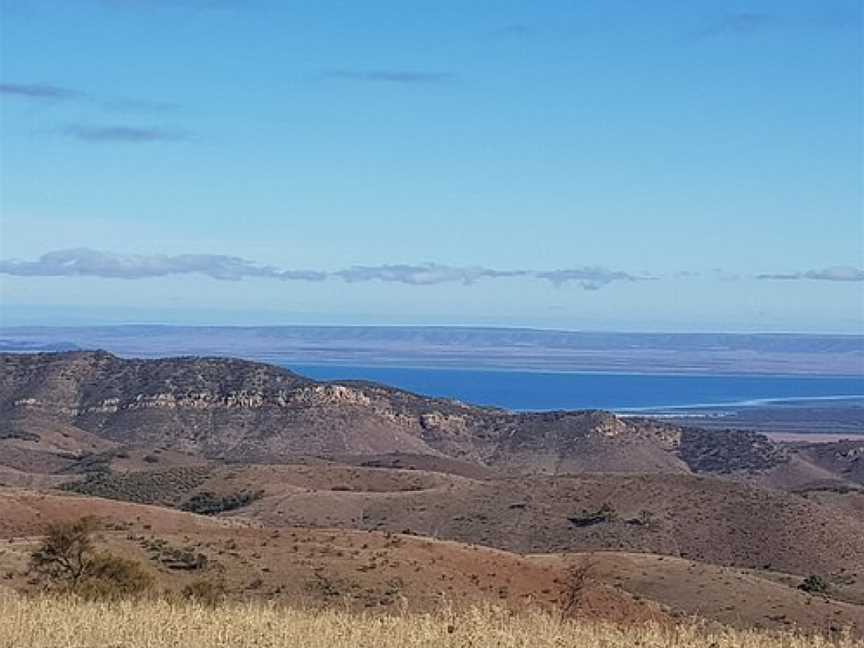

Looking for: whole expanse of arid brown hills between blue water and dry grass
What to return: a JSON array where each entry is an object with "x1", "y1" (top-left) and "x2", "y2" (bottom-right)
[{"x1": 0, "y1": 352, "x2": 864, "y2": 633}]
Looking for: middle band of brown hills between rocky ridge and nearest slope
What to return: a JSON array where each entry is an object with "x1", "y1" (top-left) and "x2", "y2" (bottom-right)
[{"x1": 57, "y1": 461, "x2": 864, "y2": 580}]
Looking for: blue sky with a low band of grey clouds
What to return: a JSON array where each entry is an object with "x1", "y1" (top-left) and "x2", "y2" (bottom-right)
[{"x1": 0, "y1": 0, "x2": 864, "y2": 333}]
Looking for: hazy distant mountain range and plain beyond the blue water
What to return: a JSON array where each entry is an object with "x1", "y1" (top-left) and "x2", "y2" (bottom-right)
[{"x1": 0, "y1": 325, "x2": 864, "y2": 376}]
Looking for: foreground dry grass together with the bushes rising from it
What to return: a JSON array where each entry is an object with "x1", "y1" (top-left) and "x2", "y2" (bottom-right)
[{"x1": 0, "y1": 518, "x2": 864, "y2": 648}]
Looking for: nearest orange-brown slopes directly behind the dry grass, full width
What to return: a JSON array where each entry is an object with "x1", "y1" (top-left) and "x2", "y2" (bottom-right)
[{"x1": 0, "y1": 489, "x2": 864, "y2": 632}]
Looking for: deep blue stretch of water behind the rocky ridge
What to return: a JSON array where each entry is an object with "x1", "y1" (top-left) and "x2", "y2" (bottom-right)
[{"x1": 286, "y1": 365, "x2": 864, "y2": 411}]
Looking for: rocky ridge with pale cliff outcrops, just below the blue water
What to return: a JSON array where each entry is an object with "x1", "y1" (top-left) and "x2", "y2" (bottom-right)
[{"x1": 0, "y1": 352, "x2": 784, "y2": 473}]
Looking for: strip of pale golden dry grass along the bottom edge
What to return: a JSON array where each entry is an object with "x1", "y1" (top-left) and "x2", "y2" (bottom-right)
[{"x1": 0, "y1": 596, "x2": 864, "y2": 648}]
